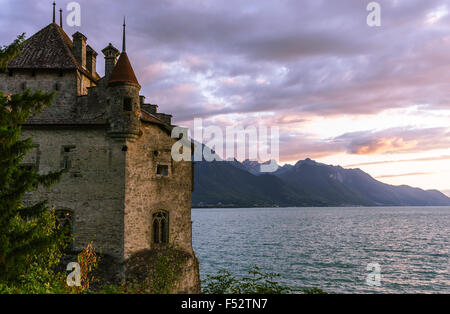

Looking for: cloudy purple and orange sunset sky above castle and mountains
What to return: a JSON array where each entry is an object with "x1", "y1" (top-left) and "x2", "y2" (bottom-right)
[{"x1": 0, "y1": 0, "x2": 450, "y2": 195}]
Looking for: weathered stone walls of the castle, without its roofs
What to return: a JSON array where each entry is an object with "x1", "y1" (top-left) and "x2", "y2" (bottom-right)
[{"x1": 0, "y1": 53, "x2": 200, "y2": 293}]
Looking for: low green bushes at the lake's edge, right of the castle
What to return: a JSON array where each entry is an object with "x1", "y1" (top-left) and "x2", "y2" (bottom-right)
[{"x1": 202, "y1": 266, "x2": 326, "y2": 294}]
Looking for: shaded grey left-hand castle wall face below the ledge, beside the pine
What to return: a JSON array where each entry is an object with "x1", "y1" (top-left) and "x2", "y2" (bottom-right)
[{"x1": 22, "y1": 127, "x2": 125, "y2": 260}]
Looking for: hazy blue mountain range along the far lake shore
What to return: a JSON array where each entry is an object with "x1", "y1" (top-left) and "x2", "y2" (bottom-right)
[{"x1": 192, "y1": 159, "x2": 450, "y2": 207}]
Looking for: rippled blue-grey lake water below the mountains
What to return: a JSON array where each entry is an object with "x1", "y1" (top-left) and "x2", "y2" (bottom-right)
[{"x1": 192, "y1": 207, "x2": 450, "y2": 293}]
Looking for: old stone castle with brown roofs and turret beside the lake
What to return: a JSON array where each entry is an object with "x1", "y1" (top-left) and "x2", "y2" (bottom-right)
[{"x1": 0, "y1": 6, "x2": 200, "y2": 293}]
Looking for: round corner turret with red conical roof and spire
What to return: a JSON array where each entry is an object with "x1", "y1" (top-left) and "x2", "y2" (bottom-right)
[{"x1": 105, "y1": 19, "x2": 141, "y2": 139}]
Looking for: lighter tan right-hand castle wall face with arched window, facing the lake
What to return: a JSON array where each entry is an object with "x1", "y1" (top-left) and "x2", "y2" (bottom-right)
[{"x1": 125, "y1": 124, "x2": 192, "y2": 257}]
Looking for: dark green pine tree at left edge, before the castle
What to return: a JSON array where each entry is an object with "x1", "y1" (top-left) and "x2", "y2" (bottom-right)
[{"x1": 0, "y1": 35, "x2": 62, "y2": 284}]
